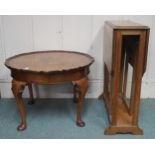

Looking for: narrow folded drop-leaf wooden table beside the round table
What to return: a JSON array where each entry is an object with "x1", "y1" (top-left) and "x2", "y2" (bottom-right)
[{"x1": 100, "y1": 21, "x2": 149, "y2": 135}]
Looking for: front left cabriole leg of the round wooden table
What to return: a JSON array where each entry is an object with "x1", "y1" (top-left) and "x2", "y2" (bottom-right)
[{"x1": 12, "y1": 80, "x2": 26, "y2": 131}]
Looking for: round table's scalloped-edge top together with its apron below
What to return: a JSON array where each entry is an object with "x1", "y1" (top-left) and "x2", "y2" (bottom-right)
[{"x1": 5, "y1": 50, "x2": 94, "y2": 84}]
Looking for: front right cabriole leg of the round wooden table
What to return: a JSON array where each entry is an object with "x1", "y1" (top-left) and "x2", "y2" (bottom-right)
[{"x1": 73, "y1": 77, "x2": 88, "y2": 127}]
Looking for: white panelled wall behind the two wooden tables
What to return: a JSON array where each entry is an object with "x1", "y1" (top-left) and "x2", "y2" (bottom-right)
[{"x1": 0, "y1": 15, "x2": 155, "y2": 98}]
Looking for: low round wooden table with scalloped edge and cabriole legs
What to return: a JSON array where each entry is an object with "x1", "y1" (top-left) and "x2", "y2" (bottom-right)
[{"x1": 5, "y1": 50, "x2": 94, "y2": 131}]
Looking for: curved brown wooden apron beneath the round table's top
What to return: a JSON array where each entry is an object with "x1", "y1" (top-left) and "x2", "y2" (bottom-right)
[{"x1": 11, "y1": 67, "x2": 89, "y2": 84}]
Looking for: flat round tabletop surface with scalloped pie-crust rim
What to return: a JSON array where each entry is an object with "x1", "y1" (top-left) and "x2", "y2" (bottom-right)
[{"x1": 5, "y1": 51, "x2": 94, "y2": 72}]
